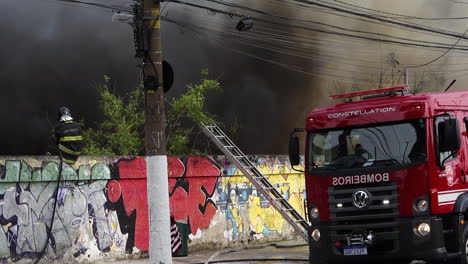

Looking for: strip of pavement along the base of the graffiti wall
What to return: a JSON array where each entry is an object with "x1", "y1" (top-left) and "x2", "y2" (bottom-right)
[{"x1": 98, "y1": 241, "x2": 309, "y2": 264}]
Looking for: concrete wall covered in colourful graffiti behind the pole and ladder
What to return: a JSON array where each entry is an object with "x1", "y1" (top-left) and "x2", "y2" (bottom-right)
[{"x1": 0, "y1": 156, "x2": 305, "y2": 262}]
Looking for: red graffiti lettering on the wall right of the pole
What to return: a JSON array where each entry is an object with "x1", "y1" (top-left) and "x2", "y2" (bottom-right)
[{"x1": 169, "y1": 157, "x2": 221, "y2": 234}]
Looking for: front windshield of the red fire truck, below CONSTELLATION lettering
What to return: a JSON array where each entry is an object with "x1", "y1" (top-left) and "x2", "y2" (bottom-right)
[{"x1": 307, "y1": 119, "x2": 426, "y2": 172}]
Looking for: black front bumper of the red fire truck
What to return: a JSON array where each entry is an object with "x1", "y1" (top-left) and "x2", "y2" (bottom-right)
[{"x1": 309, "y1": 217, "x2": 450, "y2": 263}]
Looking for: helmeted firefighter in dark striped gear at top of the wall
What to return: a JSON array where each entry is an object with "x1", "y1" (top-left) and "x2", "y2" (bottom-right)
[{"x1": 47, "y1": 107, "x2": 83, "y2": 165}]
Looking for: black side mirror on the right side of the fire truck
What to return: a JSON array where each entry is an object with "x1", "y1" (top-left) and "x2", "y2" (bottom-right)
[{"x1": 438, "y1": 117, "x2": 461, "y2": 152}]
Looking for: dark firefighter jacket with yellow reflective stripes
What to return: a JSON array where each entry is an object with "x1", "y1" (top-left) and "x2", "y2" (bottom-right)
[{"x1": 54, "y1": 121, "x2": 83, "y2": 164}]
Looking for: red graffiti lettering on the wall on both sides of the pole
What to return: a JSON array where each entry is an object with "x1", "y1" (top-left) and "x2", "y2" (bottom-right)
[{"x1": 107, "y1": 157, "x2": 221, "y2": 250}]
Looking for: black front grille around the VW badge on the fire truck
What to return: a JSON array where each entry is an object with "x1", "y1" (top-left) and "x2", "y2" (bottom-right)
[{"x1": 328, "y1": 182, "x2": 399, "y2": 252}]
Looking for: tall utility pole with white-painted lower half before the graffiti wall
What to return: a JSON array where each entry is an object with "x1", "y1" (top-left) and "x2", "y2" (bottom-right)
[{"x1": 142, "y1": 0, "x2": 172, "y2": 264}]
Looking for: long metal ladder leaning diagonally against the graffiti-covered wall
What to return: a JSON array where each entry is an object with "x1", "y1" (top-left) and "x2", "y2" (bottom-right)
[{"x1": 200, "y1": 123, "x2": 309, "y2": 241}]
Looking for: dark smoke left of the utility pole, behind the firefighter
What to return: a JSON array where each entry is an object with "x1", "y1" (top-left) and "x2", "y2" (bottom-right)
[{"x1": 0, "y1": 0, "x2": 138, "y2": 155}]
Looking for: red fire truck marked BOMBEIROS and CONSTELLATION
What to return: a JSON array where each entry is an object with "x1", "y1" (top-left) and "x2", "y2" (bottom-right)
[{"x1": 289, "y1": 86, "x2": 468, "y2": 264}]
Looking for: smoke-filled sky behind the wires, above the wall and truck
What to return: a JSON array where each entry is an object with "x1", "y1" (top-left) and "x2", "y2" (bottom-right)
[{"x1": 0, "y1": 0, "x2": 467, "y2": 155}]
